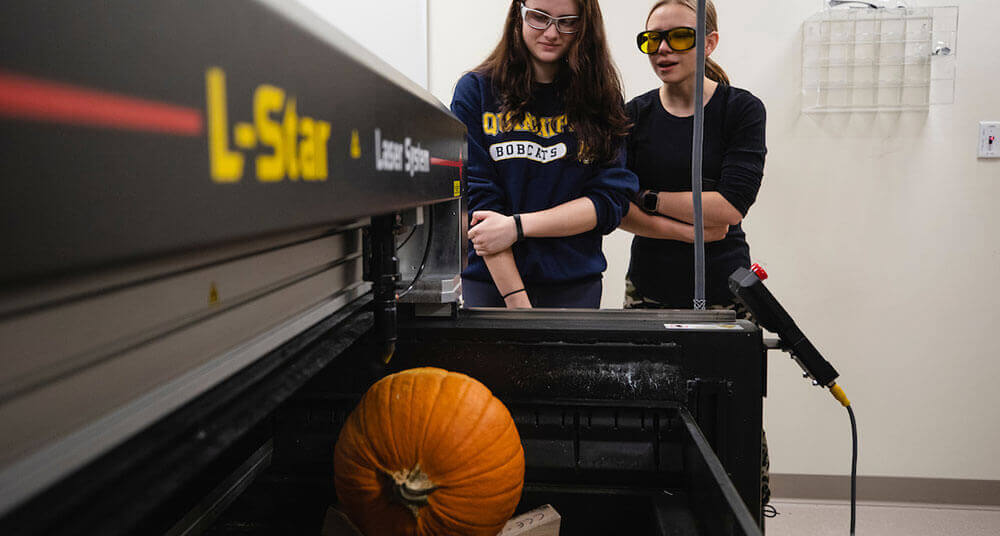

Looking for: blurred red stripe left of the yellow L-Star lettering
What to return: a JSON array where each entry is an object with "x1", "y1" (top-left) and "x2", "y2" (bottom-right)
[{"x1": 0, "y1": 71, "x2": 204, "y2": 136}]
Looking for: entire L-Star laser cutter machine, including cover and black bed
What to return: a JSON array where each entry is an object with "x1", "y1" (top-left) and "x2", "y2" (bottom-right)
[{"x1": 0, "y1": 0, "x2": 765, "y2": 535}]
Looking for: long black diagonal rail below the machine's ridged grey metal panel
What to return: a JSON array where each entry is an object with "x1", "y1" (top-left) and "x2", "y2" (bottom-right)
[{"x1": 0, "y1": 295, "x2": 373, "y2": 536}]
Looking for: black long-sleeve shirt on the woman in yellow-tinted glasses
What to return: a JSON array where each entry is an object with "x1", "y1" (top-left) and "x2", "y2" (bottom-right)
[{"x1": 626, "y1": 85, "x2": 767, "y2": 309}]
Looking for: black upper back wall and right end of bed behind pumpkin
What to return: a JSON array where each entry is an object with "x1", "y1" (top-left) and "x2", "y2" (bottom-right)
[{"x1": 390, "y1": 310, "x2": 766, "y2": 522}]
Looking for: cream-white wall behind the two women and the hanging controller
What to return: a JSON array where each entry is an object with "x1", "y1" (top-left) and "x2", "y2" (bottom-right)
[{"x1": 429, "y1": 0, "x2": 1000, "y2": 480}]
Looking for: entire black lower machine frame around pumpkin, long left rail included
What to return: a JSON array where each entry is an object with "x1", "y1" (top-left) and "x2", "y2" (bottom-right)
[{"x1": 0, "y1": 296, "x2": 763, "y2": 535}]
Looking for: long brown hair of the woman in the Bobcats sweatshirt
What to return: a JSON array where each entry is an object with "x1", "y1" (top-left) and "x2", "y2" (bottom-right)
[{"x1": 474, "y1": 0, "x2": 628, "y2": 163}]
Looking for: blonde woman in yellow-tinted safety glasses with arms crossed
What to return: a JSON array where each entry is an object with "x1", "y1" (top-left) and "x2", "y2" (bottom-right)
[{"x1": 621, "y1": 0, "x2": 771, "y2": 505}]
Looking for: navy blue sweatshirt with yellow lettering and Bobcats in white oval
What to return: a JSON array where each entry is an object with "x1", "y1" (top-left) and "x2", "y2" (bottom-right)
[{"x1": 451, "y1": 73, "x2": 639, "y2": 284}]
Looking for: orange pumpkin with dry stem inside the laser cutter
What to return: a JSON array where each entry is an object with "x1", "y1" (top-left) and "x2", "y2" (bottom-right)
[{"x1": 334, "y1": 368, "x2": 524, "y2": 536}]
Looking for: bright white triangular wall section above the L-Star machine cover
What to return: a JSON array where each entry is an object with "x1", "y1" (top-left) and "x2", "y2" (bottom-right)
[{"x1": 297, "y1": 0, "x2": 427, "y2": 88}]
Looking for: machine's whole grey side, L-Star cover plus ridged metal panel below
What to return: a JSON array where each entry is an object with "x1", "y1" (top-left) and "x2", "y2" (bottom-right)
[{"x1": 0, "y1": 0, "x2": 465, "y2": 516}]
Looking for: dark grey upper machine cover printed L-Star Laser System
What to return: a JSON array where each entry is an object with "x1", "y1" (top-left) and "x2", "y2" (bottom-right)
[{"x1": 0, "y1": 0, "x2": 465, "y2": 284}]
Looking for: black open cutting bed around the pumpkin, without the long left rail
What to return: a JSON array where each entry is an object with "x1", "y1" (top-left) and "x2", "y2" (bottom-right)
[{"x1": 201, "y1": 307, "x2": 763, "y2": 536}]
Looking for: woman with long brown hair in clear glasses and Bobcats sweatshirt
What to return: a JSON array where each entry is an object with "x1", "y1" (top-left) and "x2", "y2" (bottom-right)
[{"x1": 451, "y1": 0, "x2": 638, "y2": 308}]
